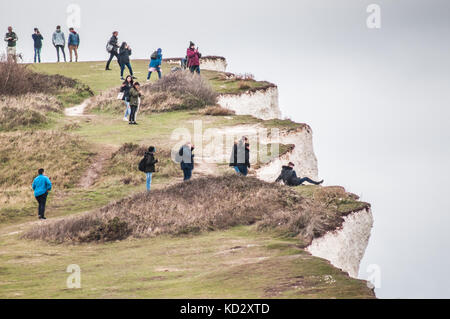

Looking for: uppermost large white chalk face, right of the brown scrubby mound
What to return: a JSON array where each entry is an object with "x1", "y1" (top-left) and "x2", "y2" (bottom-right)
[{"x1": 218, "y1": 86, "x2": 281, "y2": 120}]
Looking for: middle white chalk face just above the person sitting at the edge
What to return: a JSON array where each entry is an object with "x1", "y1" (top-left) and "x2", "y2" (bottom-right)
[{"x1": 256, "y1": 125, "x2": 319, "y2": 182}]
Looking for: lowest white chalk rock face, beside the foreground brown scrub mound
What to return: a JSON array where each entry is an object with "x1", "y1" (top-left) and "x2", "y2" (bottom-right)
[{"x1": 306, "y1": 208, "x2": 373, "y2": 278}]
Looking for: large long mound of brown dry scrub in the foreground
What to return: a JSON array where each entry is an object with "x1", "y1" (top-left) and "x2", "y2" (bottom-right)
[{"x1": 24, "y1": 174, "x2": 366, "y2": 246}]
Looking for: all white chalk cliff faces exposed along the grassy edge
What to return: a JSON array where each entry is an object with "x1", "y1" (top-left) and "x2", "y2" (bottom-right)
[{"x1": 213, "y1": 64, "x2": 373, "y2": 278}]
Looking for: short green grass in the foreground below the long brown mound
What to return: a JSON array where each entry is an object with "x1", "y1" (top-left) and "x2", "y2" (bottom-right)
[{"x1": 0, "y1": 227, "x2": 373, "y2": 298}]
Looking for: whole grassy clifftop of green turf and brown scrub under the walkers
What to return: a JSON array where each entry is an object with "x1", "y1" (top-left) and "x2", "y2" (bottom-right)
[{"x1": 0, "y1": 61, "x2": 374, "y2": 298}]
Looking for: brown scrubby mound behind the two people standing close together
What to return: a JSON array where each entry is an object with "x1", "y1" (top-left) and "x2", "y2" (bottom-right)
[{"x1": 87, "y1": 71, "x2": 217, "y2": 114}]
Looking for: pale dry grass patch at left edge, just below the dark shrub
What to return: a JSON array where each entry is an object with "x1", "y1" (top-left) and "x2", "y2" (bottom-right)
[{"x1": 0, "y1": 93, "x2": 63, "y2": 131}]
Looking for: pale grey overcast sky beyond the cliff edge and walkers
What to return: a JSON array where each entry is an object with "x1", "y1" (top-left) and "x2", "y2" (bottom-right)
[{"x1": 0, "y1": 0, "x2": 450, "y2": 298}]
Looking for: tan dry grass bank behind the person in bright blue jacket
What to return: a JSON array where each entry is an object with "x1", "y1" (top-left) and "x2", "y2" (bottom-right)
[{"x1": 0, "y1": 131, "x2": 91, "y2": 221}]
